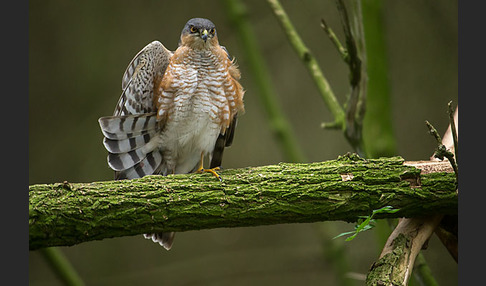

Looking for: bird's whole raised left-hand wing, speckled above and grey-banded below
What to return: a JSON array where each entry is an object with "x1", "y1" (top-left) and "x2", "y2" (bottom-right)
[{"x1": 98, "y1": 41, "x2": 172, "y2": 179}]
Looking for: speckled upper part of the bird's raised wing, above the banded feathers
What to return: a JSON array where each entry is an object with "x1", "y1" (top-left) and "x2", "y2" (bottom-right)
[{"x1": 114, "y1": 41, "x2": 173, "y2": 115}]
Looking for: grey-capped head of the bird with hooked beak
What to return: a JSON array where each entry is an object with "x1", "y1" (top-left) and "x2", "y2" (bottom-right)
[{"x1": 179, "y1": 18, "x2": 218, "y2": 49}]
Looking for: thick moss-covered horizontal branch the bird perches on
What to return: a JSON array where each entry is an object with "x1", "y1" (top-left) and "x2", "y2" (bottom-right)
[{"x1": 29, "y1": 155, "x2": 457, "y2": 250}]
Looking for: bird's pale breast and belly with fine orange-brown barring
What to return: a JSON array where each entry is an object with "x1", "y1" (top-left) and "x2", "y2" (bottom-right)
[{"x1": 159, "y1": 47, "x2": 230, "y2": 159}]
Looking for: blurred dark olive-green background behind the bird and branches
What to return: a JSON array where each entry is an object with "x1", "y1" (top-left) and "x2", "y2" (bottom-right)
[{"x1": 29, "y1": 0, "x2": 458, "y2": 285}]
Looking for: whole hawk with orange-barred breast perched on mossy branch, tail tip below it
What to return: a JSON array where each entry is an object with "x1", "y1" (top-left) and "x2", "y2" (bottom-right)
[{"x1": 98, "y1": 18, "x2": 244, "y2": 250}]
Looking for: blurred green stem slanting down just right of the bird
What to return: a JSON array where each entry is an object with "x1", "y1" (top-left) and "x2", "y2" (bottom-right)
[{"x1": 223, "y1": 0, "x2": 306, "y2": 162}]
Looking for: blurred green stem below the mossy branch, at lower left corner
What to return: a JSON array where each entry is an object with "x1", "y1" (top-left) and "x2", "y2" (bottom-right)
[{"x1": 39, "y1": 247, "x2": 84, "y2": 286}]
